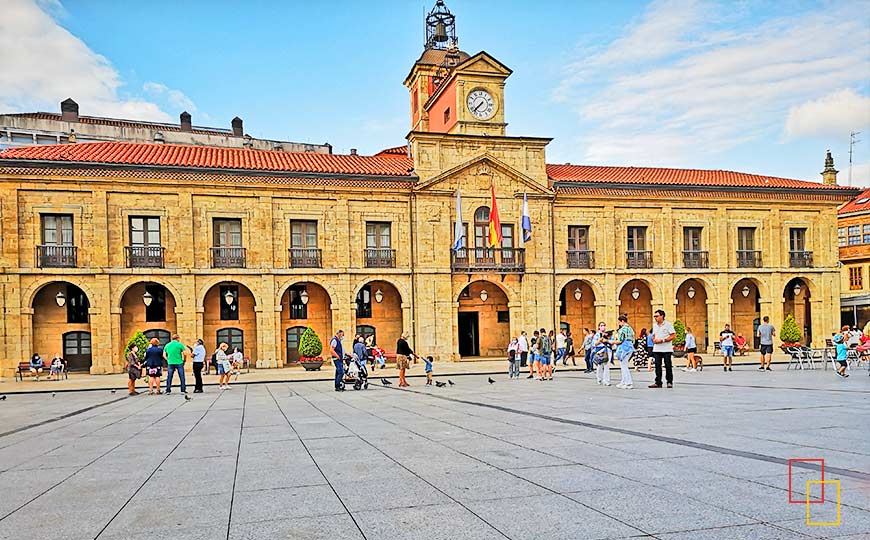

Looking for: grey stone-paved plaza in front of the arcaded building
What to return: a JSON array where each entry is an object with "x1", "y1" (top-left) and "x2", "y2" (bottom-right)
[{"x1": 0, "y1": 366, "x2": 870, "y2": 540}]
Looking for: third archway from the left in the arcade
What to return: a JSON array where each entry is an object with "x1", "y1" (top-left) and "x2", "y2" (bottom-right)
[{"x1": 202, "y1": 281, "x2": 257, "y2": 364}]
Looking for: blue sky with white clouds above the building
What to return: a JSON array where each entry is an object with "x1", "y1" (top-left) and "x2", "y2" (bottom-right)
[{"x1": 0, "y1": 0, "x2": 870, "y2": 185}]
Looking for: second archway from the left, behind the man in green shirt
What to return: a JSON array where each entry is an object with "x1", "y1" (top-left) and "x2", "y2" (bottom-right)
[{"x1": 116, "y1": 282, "x2": 178, "y2": 368}]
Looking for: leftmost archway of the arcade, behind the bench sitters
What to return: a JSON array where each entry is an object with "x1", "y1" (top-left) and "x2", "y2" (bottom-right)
[{"x1": 32, "y1": 281, "x2": 92, "y2": 371}]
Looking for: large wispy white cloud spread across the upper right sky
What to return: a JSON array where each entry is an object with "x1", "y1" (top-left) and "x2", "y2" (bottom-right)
[{"x1": 554, "y1": 0, "x2": 870, "y2": 166}]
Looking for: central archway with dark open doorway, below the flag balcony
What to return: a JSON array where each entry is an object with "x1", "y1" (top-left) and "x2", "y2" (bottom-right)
[{"x1": 457, "y1": 281, "x2": 511, "y2": 357}]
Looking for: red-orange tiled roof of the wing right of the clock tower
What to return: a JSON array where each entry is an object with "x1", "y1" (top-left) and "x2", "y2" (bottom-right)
[{"x1": 547, "y1": 165, "x2": 852, "y2": 190}]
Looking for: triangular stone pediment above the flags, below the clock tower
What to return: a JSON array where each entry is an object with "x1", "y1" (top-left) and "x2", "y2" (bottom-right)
[{"x1": 414, "y1": 153, "x2": 552, "y2": 195}]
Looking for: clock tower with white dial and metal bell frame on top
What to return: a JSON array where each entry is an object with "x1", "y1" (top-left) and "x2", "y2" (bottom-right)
[{"x1": 405, "y1": 0, "x2": 511, "y2": 136}]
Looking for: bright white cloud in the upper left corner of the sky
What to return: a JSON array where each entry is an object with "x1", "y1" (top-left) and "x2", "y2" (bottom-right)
[{"x1": 0, "y1": 0, "x2": 172, "y2": 122}]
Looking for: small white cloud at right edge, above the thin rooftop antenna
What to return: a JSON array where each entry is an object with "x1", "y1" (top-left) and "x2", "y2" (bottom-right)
[{"x1": 785, "y1": 88, "x2": 870, "y2": 137}]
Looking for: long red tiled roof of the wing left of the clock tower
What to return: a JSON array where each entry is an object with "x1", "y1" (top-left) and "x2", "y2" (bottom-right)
[{"x1": 0, "y1": 142, "x2": 413, "y2": 177}]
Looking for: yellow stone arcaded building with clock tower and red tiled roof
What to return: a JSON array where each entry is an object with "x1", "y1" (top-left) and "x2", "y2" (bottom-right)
[{"x1": 0, "y1": 1, "x2": 858, "y2": 375}]
